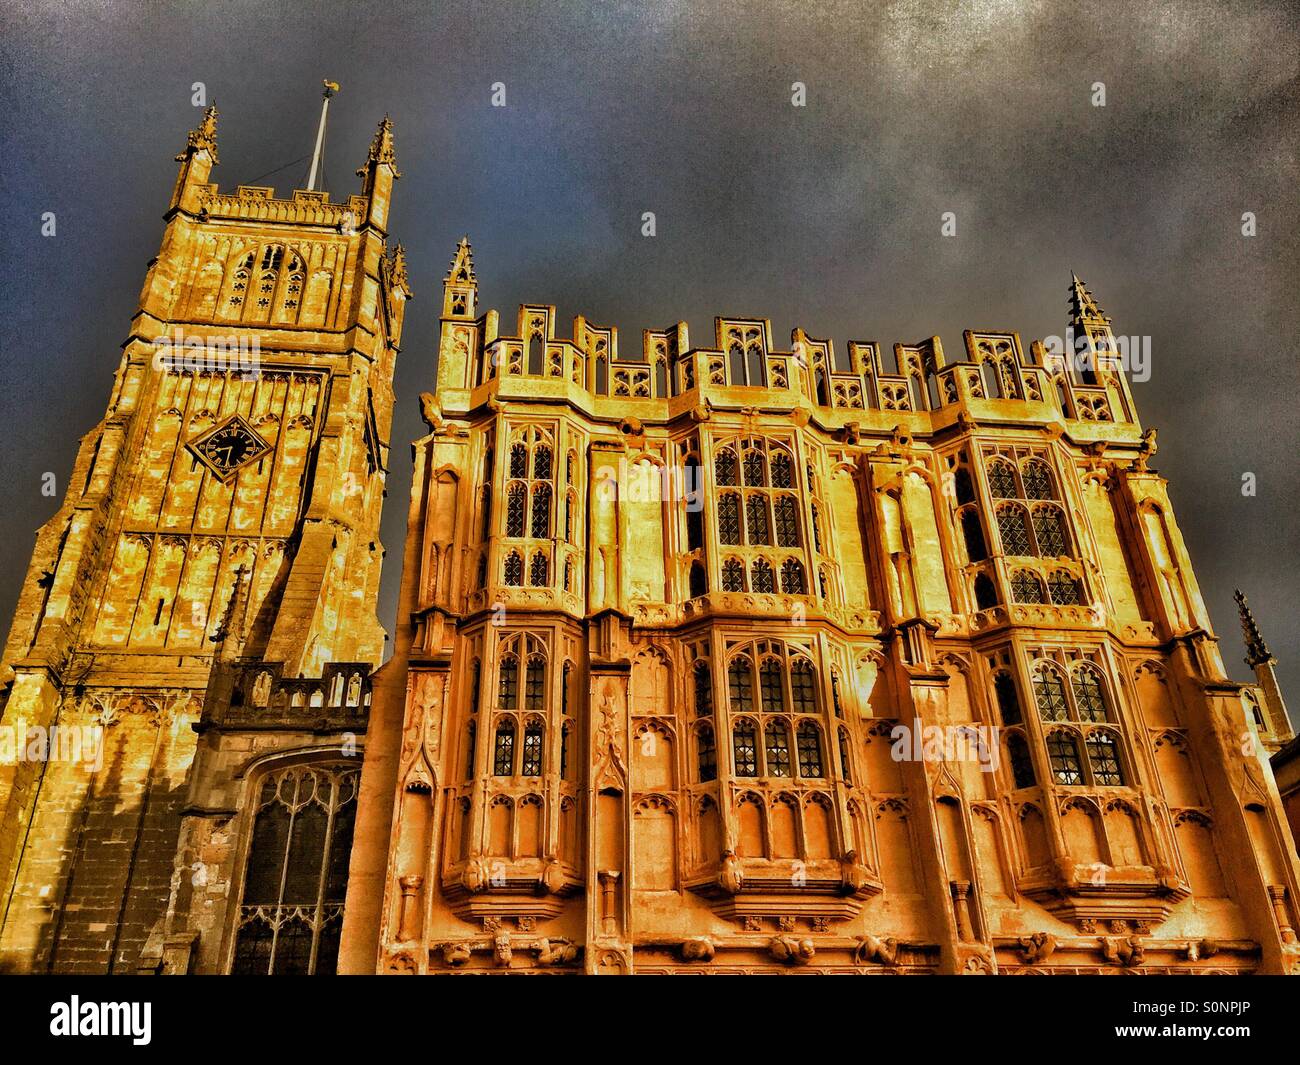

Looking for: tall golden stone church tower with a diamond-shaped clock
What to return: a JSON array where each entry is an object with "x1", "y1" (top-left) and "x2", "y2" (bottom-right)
[{"x1": 0, "y1": 108, "x2": 410, "y2": 973}]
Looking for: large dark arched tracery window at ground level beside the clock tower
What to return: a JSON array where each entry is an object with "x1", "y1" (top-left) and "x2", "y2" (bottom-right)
[{"x1": 230, "y1": 765, "x2": 360, "y2": 975}]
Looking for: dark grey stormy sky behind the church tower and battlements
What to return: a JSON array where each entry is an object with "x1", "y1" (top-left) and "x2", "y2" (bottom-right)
[{"x1": 0, "y1": 3, "x2": 1300, "y2": 700}]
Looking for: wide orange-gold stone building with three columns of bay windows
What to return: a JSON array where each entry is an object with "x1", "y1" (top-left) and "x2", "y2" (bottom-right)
[{"x1": 339, "y1": 249, "x2": 1300, "y2": 974}]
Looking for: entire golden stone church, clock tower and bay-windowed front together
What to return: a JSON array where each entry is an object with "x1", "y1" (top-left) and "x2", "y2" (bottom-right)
[{"x1": 0, "y1": 104, "x2": 1300, "y2": 974}]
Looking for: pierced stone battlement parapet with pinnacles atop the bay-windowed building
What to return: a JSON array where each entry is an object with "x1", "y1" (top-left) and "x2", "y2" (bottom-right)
[{"x1": 438, "y1": 248, "x2": 1138, "y2": 428}]
